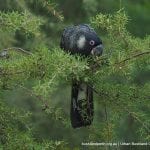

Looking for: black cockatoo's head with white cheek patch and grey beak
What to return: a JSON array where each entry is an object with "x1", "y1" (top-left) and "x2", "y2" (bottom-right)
[{"x1": 77, "y1": 32, "x2": 103, "y2": 56}]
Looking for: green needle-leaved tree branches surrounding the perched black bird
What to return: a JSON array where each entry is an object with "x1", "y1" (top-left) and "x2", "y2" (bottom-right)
[{"x1": 0, "y1": 0, "x2": 150, "y2": 149}]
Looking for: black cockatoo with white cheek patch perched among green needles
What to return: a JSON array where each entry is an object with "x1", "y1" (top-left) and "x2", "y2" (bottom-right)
[{"x1": 60, "y1": 24, "x2": 103, "y2": 128}]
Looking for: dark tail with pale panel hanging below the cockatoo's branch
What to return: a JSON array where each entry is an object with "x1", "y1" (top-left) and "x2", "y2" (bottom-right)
[{"x1": 70, "y1": 81, "x2": 94, "y2": 128}]
